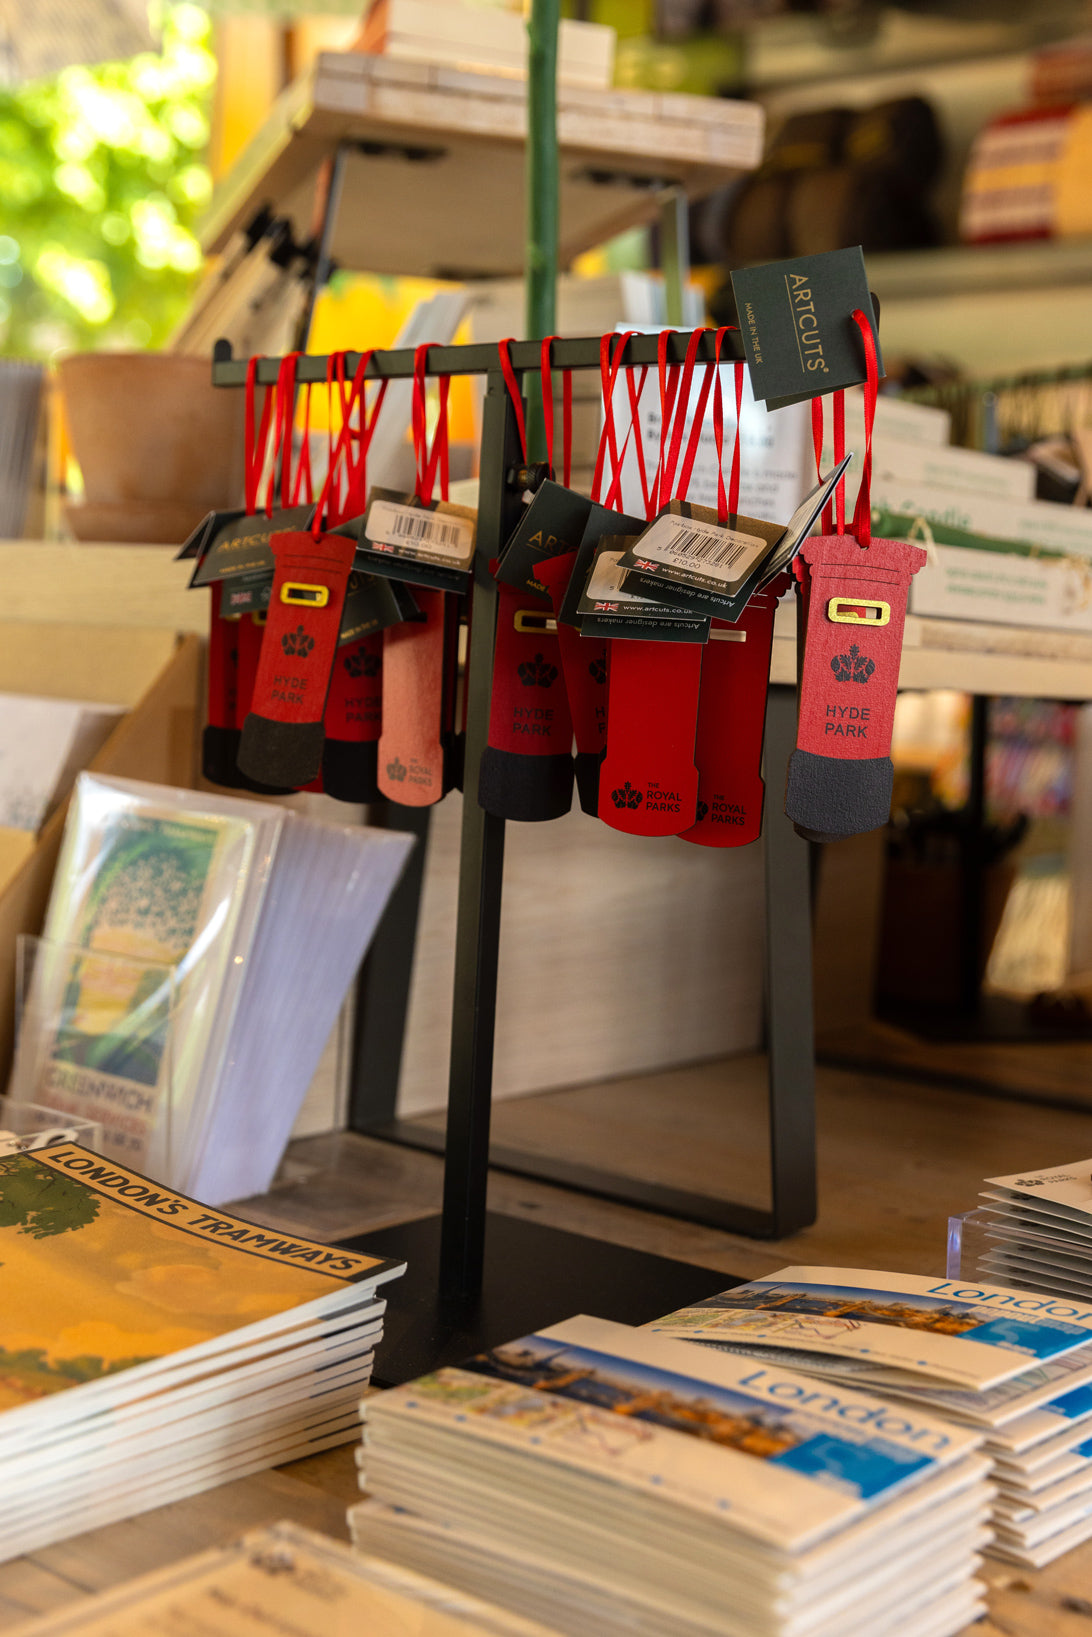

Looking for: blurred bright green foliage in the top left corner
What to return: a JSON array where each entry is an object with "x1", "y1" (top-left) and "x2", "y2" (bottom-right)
[{"x1": 0, "y1": 0, "x2": 216, "y2": 357}]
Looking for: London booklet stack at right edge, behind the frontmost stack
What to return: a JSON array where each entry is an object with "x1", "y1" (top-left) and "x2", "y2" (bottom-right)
[{"x1": 648, "y1": 1267, "x2": 1092, "y2": 1568}]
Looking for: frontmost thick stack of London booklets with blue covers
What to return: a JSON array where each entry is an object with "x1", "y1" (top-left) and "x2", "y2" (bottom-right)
[{"x1": 350, "y1": 1318, "x2": 990, "y2": 1637}]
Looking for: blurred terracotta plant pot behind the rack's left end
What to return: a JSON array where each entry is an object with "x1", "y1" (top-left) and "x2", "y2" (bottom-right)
[{"x1": 59, "y1": 352, "x2": 244, "y2": 524}]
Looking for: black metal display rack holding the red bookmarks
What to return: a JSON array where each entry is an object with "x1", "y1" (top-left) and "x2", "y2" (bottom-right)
[{"x1": 213, "y1": 331, "x2": 817, "y2": 1380}]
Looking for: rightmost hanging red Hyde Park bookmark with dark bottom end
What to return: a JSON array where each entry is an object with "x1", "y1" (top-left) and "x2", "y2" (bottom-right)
[{"x1": 784, "y1": 534, "x2": 927, "y2": 840}]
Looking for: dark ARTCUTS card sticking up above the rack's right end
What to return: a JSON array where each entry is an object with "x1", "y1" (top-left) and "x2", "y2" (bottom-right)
[{"x1": 730, "y1": 244, "x2": 884, "y2": 408}]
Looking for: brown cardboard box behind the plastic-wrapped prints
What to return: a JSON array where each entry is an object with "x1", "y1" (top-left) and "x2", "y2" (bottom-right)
[{"x1": 0, "y1": 622, "x2": 203, "y2": 1084}]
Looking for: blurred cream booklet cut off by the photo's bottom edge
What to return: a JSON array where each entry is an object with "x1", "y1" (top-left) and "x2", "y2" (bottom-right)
[{"x1": 20, "y1": 1524, "x2": 563, "y2": 1637}]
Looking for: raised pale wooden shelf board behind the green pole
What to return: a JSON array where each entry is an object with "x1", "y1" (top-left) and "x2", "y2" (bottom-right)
[{"x1": 203, "y1": 52, "x2": 765, "y2": 278}]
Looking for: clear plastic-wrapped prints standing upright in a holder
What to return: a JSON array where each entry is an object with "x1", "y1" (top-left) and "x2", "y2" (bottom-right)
[{"x1": 10, "y1": 773, "x2": 413, "y2": 1205}]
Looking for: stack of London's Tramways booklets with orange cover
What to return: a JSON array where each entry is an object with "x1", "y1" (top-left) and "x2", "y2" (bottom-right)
[{"x1": 0, "y1": 1143, "x2": 404, "y2": 1560}]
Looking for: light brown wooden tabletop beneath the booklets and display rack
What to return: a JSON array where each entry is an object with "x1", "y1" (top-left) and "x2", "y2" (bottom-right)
[{"x1": 0, "y1": 1093, "x2": 1092, "y2": 1637}]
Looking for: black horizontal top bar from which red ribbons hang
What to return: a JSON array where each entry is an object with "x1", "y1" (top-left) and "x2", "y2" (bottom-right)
[{"x1": 213, "y1": 329, "x2": 743, "y2": 386}]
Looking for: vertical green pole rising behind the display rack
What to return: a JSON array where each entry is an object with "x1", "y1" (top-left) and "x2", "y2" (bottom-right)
[{"x1": 524, "y1": 0, "x2": 562, "y2": 460}]
